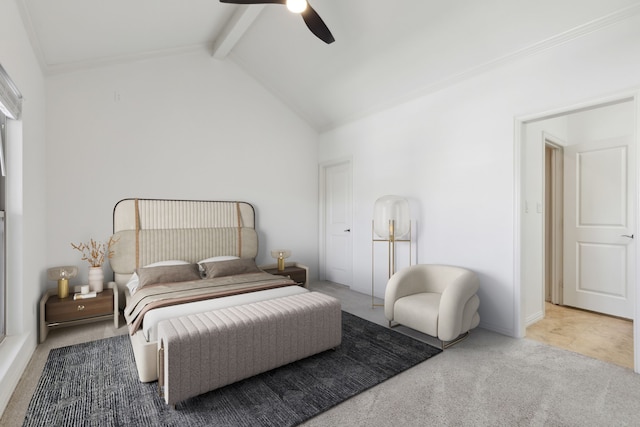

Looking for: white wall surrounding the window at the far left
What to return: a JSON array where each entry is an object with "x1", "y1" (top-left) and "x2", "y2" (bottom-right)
[{"x1": 0, "y1": 0, "x2": 46, "y2": 413}]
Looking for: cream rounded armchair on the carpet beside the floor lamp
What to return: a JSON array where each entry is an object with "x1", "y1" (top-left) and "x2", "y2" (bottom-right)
[{"x1": 384, "y1": 264, "x2": 480, "y2": 349}]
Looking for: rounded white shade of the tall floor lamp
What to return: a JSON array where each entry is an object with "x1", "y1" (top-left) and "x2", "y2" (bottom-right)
[{"x1": 373, "y1": 196, "x2": 411, "y2": 240}]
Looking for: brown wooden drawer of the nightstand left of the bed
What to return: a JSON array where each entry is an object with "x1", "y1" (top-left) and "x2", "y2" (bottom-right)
[{"x1": 45, "y1": 289, "x2": 113, "y2": 322}]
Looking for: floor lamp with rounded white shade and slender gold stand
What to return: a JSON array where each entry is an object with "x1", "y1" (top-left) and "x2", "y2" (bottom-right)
[{"x1": 371, "y1": 196, "x2": 411, "y2": 307}]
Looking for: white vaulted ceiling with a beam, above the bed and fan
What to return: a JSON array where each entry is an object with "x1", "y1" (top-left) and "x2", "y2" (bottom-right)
[{"x1": 16, "y1": 0, "x2": 640, "y2": 131}]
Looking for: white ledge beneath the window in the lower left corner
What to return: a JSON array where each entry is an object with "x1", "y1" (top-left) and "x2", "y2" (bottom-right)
[{"x1": 0, "y1": 333, "x2": 36, "y2": 416}]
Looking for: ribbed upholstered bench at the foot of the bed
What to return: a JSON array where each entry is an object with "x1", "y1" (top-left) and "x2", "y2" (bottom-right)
[{"x1": 158, "y1": 292, "x2": 342, "y2": 407}]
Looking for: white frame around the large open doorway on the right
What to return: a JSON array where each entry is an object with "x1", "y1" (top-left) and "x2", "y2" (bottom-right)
[{"x1": 513, "y1": 89, "x2": 640, "y2": 373}]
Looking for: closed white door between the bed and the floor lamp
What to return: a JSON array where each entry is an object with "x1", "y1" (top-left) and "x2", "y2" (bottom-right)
[{"x1": 324, "y1": 162, "x2": 352, "y2": 286}]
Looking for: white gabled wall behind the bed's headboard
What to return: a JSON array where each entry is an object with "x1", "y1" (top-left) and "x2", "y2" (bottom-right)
[{"x1": 46, "y1": 52, "x2": 318, "y2": 288}]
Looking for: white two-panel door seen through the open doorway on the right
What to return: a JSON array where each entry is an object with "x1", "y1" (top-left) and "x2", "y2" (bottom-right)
[{"x1": 563, "y1": 137, "x2": 636, "y2": 318}]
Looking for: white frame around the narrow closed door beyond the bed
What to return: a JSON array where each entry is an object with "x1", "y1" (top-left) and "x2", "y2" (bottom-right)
[{"x1": 318, "y1": 156, "x2": 353, "y2": 285}]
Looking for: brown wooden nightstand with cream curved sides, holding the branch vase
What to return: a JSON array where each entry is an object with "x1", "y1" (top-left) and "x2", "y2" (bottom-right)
[{"x1": 40, "y1": 282, "x2": 120, "y2": 342}]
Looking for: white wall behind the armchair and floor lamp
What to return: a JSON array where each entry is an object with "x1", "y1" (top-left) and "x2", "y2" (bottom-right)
[{"x1": 319, "y1": 11, "x2": 640, "y2": 336}]
